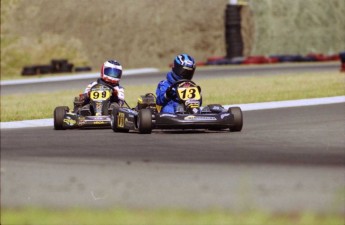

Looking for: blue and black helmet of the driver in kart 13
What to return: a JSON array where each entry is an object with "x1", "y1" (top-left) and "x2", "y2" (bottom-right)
[{"x1": 172, "y1": 54, "x2": 195, "y2": 80}]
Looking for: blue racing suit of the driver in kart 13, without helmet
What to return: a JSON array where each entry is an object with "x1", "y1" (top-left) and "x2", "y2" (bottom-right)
[{"x1": 156, "y1": 71, "x2": 201, "y2": 114}]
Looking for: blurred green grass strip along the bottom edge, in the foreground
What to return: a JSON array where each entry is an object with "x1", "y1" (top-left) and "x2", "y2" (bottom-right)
[{"x1": 1, "y1": 208, "x2": 345, "y2": 225}]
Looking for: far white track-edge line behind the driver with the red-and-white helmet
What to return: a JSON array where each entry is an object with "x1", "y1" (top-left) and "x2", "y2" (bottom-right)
[{"x1": 0, "y1": 68, "x2": 159, "y2": 86}]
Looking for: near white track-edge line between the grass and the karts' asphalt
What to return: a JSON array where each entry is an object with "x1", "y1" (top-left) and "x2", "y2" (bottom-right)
[{"x1": 0, "y1": 96, "x2": 345, "y2": 129}]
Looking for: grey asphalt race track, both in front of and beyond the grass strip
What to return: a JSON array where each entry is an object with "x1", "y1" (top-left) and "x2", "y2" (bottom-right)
[{"x1": 1, "y1": 62, "x2": 345, "y2": 214}]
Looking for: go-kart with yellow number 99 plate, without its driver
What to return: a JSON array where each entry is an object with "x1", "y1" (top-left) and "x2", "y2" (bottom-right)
[{"x1": 54, "y1": 84, "x2": 120, "y2": 130}]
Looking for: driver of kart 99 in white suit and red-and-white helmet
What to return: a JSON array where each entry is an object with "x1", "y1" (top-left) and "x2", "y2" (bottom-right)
[{"x1": 74, "y1": 60, "x2": 125, "y2": 112}]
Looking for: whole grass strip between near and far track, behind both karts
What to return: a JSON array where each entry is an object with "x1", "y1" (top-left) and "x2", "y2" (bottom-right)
[{"x1": 1, "y1": 72, "x2": 345, "y2": 122}]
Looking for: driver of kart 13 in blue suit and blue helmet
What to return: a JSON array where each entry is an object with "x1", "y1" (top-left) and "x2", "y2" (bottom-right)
[{"x1": 156, "y1": 54, "x2": 201, "y2": 113}]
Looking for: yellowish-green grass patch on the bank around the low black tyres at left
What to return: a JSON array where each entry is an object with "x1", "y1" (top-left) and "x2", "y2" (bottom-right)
[{"x1": 1, "y1": 35, "x2": 88, "y2": 80}]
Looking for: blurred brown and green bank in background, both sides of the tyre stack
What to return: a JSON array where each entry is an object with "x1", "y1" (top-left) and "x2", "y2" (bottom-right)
[{"x1": 1, "y1": 0, "x2": 345, "y2": 78}]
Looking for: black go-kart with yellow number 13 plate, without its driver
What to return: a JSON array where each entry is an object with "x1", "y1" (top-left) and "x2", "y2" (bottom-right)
[{"x1": 111, "y1": 80, "x2": 243, "y2": 134}]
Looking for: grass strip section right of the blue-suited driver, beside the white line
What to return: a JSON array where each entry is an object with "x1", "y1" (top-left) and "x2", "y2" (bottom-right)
[{"x1": 199, "y1": 72, "x2": 345, "y2": 104}]
